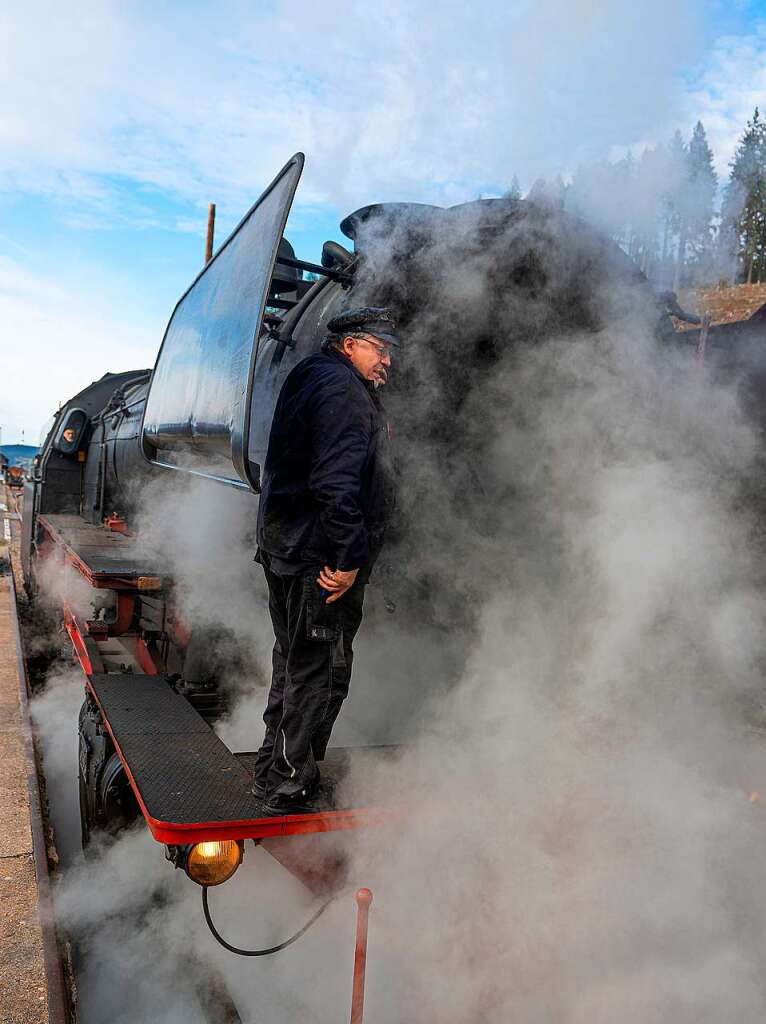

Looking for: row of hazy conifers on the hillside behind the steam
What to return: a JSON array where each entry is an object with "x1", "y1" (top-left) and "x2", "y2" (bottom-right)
[{"x1": 514, "y1": 108, "x2": 766, "y2": 291}]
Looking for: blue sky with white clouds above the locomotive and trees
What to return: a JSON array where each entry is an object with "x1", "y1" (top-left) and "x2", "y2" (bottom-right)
[{"x1": 0, "y1": 0, "x2": 766, "y2": 442}]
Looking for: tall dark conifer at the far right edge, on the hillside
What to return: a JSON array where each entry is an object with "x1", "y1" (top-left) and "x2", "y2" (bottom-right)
[{"x1": 721, "y1": 108, "x2": 766, "y2": 284}]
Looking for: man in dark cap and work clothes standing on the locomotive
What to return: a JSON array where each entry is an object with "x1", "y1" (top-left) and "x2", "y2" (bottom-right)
[{"x1": 253, "y1": 307, "x2": 399, "y2": 815}]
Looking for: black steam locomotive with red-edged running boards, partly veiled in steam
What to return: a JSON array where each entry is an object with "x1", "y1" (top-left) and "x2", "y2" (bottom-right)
[{"x1": 23, "y1": 154, "x2": 700, "y2": 885}]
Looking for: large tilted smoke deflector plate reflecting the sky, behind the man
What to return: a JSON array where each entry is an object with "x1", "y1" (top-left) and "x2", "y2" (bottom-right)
[{"x1": 141, "y1": 153, "x2": 304, "y2": 492}]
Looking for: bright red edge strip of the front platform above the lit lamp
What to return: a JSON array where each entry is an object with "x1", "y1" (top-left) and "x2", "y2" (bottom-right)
[{"x1": 86, "y1": 680, "x2": 403, "y2": 846}]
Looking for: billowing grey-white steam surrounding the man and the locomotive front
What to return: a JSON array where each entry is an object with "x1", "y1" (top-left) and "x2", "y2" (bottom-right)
[{"x1": 23, "y1": 75, "x2": 766, "y2": 1024}]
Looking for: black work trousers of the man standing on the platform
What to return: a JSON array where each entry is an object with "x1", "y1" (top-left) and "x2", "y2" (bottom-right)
[{"x1": 255, "y1": 565, "x2": 365, "y2": 797}]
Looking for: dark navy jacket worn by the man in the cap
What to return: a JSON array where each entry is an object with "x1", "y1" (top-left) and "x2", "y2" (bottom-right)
[{"x1": 257, "y1": 349, "x2": 391, "y2": 570}]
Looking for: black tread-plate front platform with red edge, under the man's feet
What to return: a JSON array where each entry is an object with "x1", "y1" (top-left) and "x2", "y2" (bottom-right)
[{"x1": 87, "y1": 673, "x2": 402, "y2": 846}]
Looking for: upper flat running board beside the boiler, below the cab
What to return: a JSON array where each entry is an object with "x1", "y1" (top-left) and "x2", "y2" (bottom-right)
[{"x1": 39, "y1": 514, "x2": 164, "y2": 579}]
